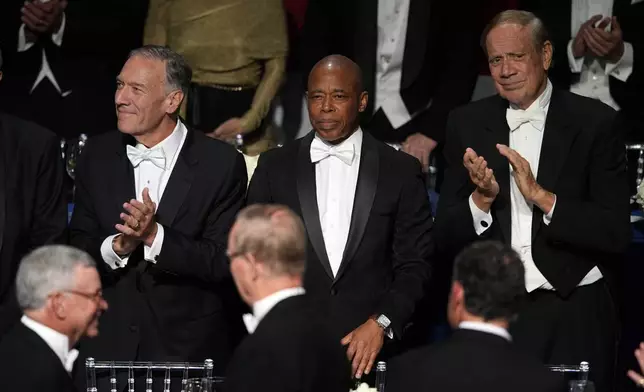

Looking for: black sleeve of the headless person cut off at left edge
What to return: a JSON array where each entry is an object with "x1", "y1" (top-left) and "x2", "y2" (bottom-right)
[{"x1": 29, "y1": 135, "x2": 67, "y2": 248}]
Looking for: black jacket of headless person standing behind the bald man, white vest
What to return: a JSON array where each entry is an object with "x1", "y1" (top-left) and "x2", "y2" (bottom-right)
[{"x1": 302, "y1": 0, "x2": 483, "y2": 142}]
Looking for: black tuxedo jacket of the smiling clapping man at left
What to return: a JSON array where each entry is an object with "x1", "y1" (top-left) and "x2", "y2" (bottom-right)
[{"x1": 70, "y1": 130, "x2": 247, "y2": 372}]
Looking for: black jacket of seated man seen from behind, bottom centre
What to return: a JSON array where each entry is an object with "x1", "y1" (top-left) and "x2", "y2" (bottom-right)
[{"x1": 224, "y1": 295, "x2": 351, "y2": 392}]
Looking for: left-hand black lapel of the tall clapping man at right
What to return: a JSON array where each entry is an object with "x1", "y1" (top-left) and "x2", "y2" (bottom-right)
[{"x1": 486, "y1": 96, "x2": 512, "y2": 243}]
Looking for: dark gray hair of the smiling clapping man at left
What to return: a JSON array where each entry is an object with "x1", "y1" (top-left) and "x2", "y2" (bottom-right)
[{"x1": 128, "y1": 45, "x2": 192, "y2": 94}]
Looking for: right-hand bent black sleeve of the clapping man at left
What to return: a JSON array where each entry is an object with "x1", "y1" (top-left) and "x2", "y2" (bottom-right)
[{"x1": 152, "y1": 153, "x2": 247, "y2": 282}]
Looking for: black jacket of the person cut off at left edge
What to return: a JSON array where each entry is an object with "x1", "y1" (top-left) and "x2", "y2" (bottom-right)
[{"x1": 0, "y1": 113, "x2": 67, "y2": 337}]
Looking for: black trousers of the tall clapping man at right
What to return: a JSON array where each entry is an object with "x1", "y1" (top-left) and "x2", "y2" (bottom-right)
[{"x1": 510, "y1": 279, "x2": 618, "y2": 392}]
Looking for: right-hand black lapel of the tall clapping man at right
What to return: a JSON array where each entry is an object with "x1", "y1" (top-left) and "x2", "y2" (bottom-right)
[{"x1": 532, "y1": 89, "x2": 579, "y2": 239}]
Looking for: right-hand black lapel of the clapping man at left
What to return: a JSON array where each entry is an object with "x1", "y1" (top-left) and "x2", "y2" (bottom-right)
[{"x1": 156, "y1": 129, "x2": 197, "y2": 227}]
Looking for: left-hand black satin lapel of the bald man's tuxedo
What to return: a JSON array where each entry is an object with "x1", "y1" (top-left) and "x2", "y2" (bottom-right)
[{"x1": 296, "y1": 131, "x2": 333, "y2": 279}]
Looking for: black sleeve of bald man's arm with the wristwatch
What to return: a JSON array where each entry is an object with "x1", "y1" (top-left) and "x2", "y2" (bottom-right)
[{"x1": 377, "y1": 157, "x2": 434, "y2": 338}]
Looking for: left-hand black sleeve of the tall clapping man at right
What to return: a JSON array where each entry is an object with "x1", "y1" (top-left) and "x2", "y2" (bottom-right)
[{"x1": 435, "y1": 112, "x2": 488, "y2": 254}]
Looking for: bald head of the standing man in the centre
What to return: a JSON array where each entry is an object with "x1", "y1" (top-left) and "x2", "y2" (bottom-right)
[{"x1": 307, "y1": 55, "x2": 368, "y2": 144}]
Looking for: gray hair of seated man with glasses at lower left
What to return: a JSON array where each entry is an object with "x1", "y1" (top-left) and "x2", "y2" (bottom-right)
[{"x1": 16, "y1": 245, "x2": 96, "y2": 310}]
